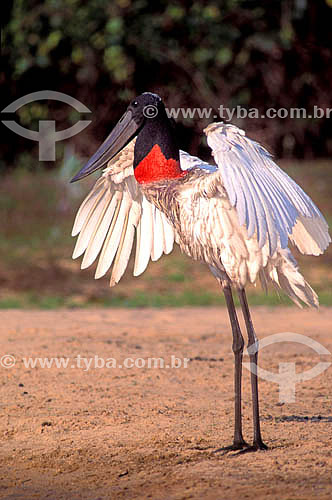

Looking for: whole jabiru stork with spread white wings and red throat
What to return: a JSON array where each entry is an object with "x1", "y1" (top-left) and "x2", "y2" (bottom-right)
[{"x1": 72, "y1": 92, "x2": 331, "y2": 453}]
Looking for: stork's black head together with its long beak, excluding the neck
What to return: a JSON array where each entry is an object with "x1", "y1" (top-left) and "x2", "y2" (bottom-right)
[{"x1": 71, "y1": 92, "x2": 167, "y2": 182}]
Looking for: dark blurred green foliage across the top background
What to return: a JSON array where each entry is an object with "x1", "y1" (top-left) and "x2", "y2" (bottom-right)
[{"x1": 0, "y1": 0, "x2": 332, "y2": 170}]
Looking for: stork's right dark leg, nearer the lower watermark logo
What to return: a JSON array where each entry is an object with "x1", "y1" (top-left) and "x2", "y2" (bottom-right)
[{"x1": 238, "y1": 289, "x2": 267, "y2": 450}]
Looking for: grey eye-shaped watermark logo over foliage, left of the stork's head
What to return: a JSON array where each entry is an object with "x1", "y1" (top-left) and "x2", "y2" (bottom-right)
[{"x1": 2, "y1": 90, "x2": 91, "y2": 161}]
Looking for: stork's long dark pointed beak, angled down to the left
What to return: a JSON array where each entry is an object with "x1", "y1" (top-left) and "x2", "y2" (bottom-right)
[{"x1": 70, "y1": 110, "x2": 140, "y2": 182}]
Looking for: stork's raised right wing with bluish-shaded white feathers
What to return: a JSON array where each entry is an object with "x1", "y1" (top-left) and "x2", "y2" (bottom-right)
[{"x1": 205, "y1": 122, "x2": 331, "y2": 255}]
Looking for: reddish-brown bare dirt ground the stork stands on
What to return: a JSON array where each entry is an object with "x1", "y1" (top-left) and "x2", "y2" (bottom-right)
[{"x1": 0, "y1": 308, "x2": 332, "y2": 500}]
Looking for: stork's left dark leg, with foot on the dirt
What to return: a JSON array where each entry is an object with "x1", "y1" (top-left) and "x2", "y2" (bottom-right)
[{"x1": 218, "y1": 285, "x2": 248, "y2": 451}]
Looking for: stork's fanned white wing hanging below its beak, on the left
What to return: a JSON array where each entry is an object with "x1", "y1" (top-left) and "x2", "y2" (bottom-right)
[{"x1": 72, "y1": 140, "x2": 175, "y2": 286}]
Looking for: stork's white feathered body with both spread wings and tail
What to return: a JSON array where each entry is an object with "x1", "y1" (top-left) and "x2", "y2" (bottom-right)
[{"x1": 73, "y1": 123, "x2": 331, "y2": 306}]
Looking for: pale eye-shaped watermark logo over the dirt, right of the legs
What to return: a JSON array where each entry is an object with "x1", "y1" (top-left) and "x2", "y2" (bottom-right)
[{"x1": 243, "y1": 332, "x2": 331, "y2": 403}]
